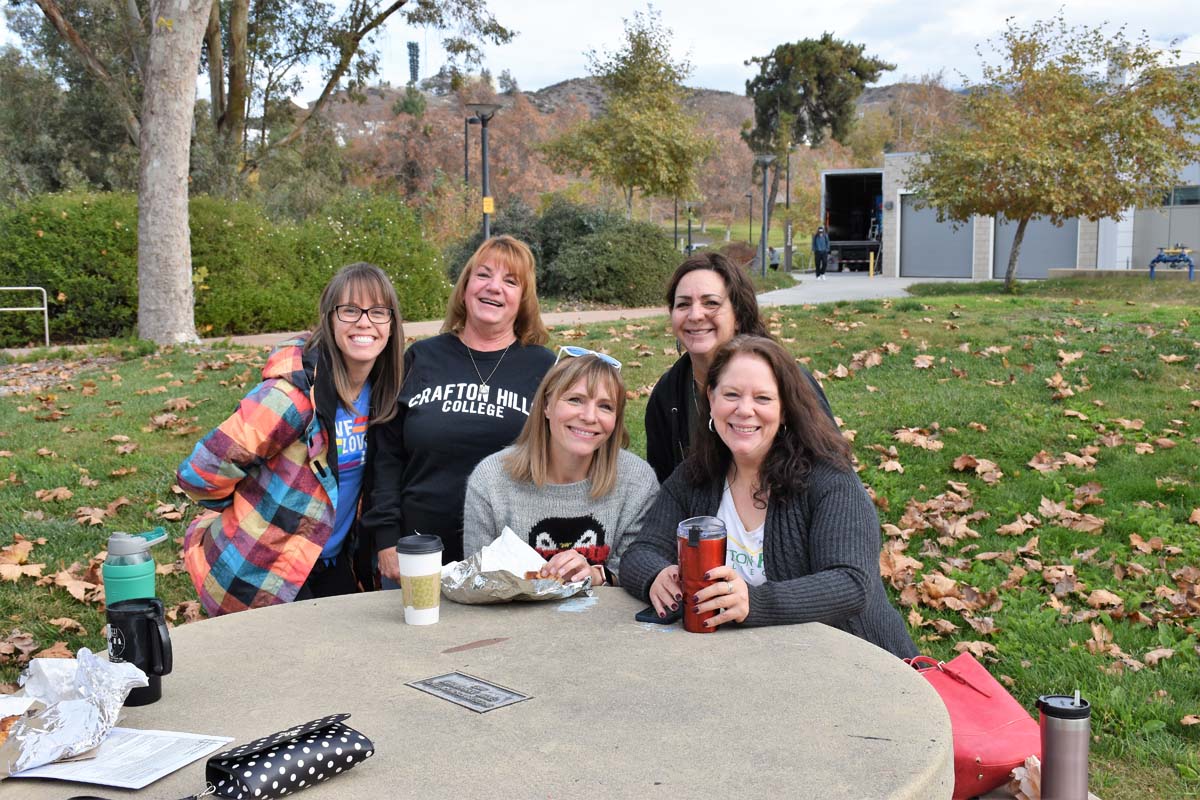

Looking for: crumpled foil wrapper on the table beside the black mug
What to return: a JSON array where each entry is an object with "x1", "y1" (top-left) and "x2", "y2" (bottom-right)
[{"x1": 0, "y1": 648, "x2": 150, "y2": 778}]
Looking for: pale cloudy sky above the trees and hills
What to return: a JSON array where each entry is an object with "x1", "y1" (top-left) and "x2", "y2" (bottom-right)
[{"x1": 0, "y1": 0, "x2": 1200, "y2": 101}]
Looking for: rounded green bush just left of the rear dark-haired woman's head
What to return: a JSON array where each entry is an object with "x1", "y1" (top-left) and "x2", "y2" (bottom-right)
[{"x1": 545, "y1": 222, "x2": 679, "y2": 306}]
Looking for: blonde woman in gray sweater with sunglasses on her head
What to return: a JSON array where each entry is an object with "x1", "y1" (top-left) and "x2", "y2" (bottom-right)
[{"x1": 463, "y1": 347, "x2": 659, "y2": 585}]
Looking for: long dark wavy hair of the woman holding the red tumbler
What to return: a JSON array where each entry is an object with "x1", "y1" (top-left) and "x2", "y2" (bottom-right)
[{"x1": 685, "y1": 336, "x2": 853, "y2": 505}]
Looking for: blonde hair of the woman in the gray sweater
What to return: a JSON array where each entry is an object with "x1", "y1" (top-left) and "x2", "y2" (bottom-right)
[{"x1": 504, "y1": 355, "x2": 629, "y2": 499}]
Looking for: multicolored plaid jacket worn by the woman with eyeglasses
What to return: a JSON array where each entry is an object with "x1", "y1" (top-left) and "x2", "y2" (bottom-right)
[{"x1": 176, "y1": 337, "x2": 337, "y2": 615}]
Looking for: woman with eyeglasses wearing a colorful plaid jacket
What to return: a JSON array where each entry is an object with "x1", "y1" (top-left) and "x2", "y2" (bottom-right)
[{"x1": 176, "y1": 263, "x2": 404, "y2": 615}]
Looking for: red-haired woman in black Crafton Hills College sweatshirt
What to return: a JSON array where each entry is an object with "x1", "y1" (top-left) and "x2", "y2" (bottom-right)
[{"x1": 364, "y1": 236, "x2": 554, "y2": 578}]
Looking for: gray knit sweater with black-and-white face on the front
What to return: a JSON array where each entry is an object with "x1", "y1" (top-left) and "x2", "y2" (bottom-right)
[{"x1": 462, "y1": 449, "x2": 659, "y2": 585}]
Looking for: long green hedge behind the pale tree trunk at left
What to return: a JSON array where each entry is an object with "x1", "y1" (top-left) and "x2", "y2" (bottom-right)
[{"x1": 0, "y1": 193, "x2": 450, "y2": 347}]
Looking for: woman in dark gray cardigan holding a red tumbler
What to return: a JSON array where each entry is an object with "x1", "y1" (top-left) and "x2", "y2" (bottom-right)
[{"x1": 622, "y1": 336, "x2": 917, "y2": 657}]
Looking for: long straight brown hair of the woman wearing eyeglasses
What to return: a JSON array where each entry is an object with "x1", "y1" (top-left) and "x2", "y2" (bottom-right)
[{"x1": 305, "y1": 261, "x2": 404, "y2": 425}]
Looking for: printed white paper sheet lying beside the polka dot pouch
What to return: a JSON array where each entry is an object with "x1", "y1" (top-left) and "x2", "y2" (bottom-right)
[{"x1": 11, "y1": 728, "x2": 233, "y2": 792}]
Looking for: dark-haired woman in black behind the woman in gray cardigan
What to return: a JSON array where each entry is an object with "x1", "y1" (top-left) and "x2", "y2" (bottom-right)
[{"x1": 646, "y1": 253, "x2": 833, "y2": 482}]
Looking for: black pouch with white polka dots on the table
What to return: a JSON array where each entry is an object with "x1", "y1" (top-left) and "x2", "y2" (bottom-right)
[{"x1": 204, "y1": 714, "x2": 374, "y2": 800}]
